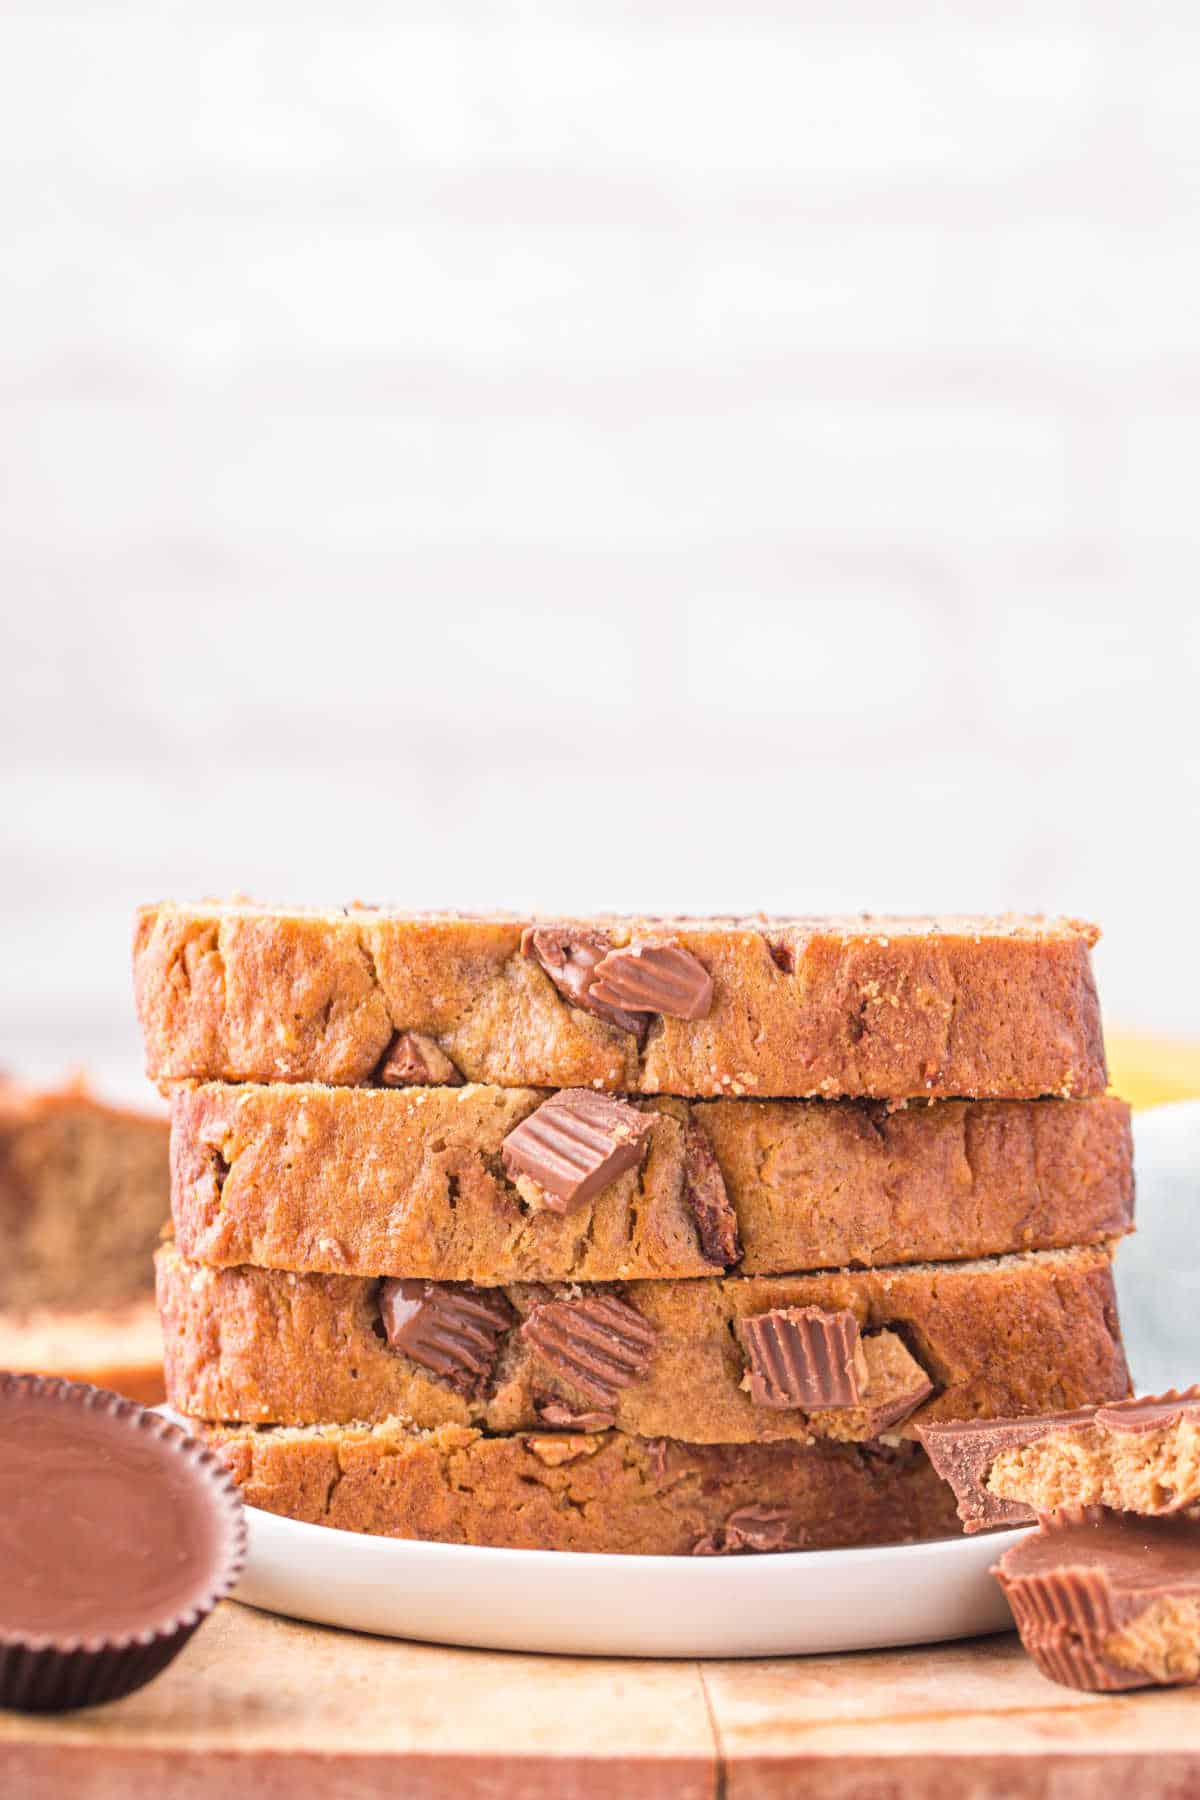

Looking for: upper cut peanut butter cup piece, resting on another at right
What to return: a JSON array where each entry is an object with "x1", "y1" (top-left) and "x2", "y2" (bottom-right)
[{"x1": 919, "y1": 1388, "x2": 1200, "y2": 1532}]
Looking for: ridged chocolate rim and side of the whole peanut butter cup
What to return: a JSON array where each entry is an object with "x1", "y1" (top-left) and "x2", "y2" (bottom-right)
[{"x1": 0, "y1": 1370, "x2": 246, "y2": 1712}]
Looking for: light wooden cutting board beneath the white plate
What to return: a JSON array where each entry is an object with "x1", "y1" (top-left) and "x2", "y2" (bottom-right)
[{"x1": 0, "y1": 1604, "x2": 1200, "y2": 1800}]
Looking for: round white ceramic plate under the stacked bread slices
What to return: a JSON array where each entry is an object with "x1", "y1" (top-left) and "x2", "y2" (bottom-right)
[{"x1": 237, "y1": 1507, "x2": 1022, "y2": 1658}]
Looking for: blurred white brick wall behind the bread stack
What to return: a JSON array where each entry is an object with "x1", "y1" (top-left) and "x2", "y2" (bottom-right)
[{"x1": 0, "y1": 0, "x2": 1200, "y2": 1080}]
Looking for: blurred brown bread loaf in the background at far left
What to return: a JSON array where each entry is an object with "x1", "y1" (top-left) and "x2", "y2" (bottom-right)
[{"x1": 0, "y1": 1082, "x2": 169, "y2": 1310}]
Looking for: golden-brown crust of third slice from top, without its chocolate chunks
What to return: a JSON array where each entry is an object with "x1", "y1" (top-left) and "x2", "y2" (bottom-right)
[{"x1": 158, "y1": 1246, "x2": 1128, "y2": 1444}]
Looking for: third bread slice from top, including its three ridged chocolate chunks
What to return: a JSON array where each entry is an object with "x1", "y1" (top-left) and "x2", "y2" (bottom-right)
[{"x1": 158, "y1": 1246, "x2": 1128, "y2": 1444}]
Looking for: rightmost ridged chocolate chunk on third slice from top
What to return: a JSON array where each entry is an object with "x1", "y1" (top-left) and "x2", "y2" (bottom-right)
[{"x1": 738, "y1": 1307, "x2": 865, "y2": 1413}]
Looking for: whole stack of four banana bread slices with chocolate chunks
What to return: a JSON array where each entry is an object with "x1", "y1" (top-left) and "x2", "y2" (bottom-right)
[{"x1": 135, "y1": 902, "x2": 1132, "y2": 1553}]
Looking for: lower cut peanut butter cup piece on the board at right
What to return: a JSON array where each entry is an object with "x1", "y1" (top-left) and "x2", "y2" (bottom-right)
[{"x1": 993, "y1": 1507, "x2": 1200, "y2": 1690}]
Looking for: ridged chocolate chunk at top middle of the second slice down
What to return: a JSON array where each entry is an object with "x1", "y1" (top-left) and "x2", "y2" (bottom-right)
[{"x1": 500, "y1": 1087, "x2": 653, "y2": 1213}]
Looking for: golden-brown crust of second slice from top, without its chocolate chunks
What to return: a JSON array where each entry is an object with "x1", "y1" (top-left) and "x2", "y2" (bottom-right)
[{"x1": 171, "y1": 1084, "x2": 1133, "y2": 1283}]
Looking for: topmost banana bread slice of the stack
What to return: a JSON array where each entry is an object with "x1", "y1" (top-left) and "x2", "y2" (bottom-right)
[{"x1": 133, "y1": 902, "x2": 1106, "y2": 1100}]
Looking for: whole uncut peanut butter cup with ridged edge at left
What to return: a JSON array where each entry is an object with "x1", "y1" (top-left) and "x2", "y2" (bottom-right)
[{"x1": 0, "y1": 1372, "x2": 246, "y2": 1712}]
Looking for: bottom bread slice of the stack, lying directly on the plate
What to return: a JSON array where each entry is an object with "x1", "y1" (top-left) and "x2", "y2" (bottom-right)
[{"x1": 201, "y1": 1418, "x2": 959, "y2": 1555}]
